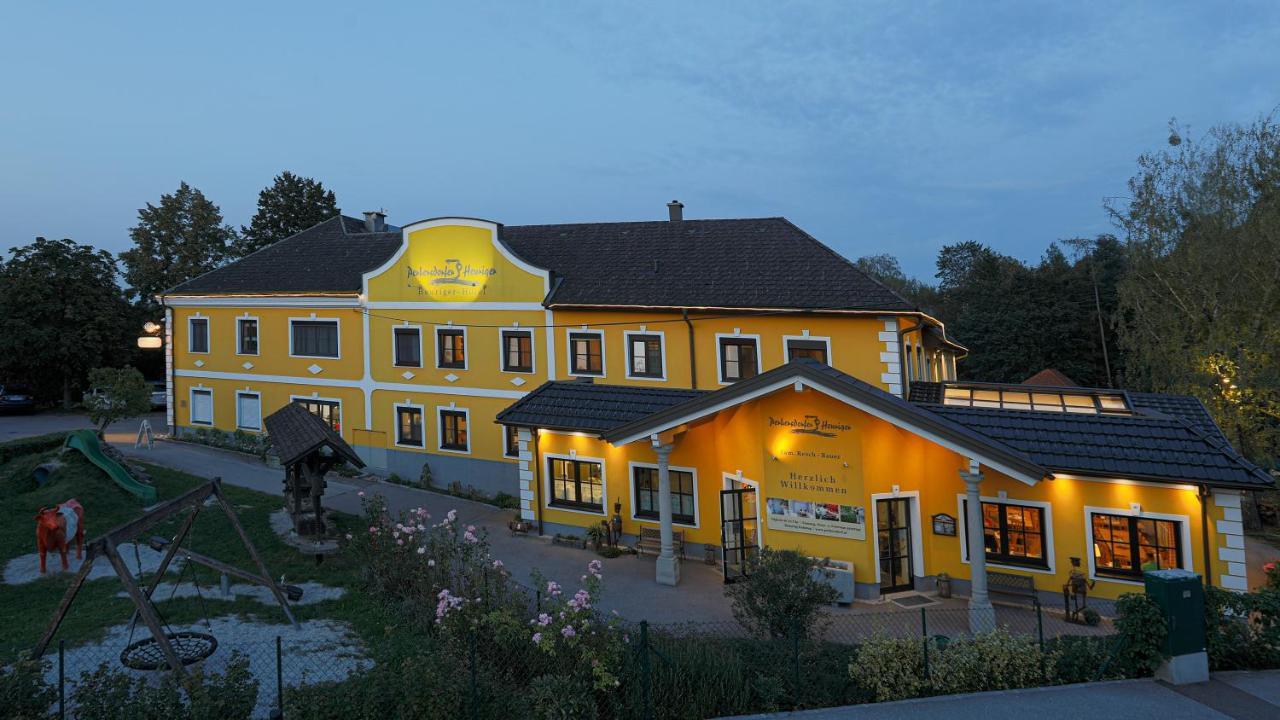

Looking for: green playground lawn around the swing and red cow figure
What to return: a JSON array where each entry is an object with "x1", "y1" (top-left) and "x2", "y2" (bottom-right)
[{"x1": 0, "y1": 438, "x2": 381, "y2": 664}]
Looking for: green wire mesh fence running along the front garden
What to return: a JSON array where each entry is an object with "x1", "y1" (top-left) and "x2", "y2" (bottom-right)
[{"x1": 46, "y1": 597, "x2": 1114, "y2": 720}]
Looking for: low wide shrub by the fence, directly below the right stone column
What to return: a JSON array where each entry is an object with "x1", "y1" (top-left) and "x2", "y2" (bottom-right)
[{"x1": 931, "y1": 628, "x2": 1052, "y2": 694}]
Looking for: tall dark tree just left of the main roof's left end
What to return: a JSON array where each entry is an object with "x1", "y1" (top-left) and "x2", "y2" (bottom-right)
[{"x1": 120, "y1": 182, "x2": 236, "y2": 307}]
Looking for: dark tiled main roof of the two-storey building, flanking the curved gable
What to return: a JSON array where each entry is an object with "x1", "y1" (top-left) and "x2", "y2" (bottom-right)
[{"x1": 169, "y1": 217, "x2": 914, "y2": 310}]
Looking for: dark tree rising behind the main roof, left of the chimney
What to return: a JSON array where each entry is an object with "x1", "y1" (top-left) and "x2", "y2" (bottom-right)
[{"x1": 234, "y1": 170, "x2": 338, "y2": 258}]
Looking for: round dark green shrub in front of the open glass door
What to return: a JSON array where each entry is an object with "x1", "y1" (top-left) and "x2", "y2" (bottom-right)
[{"x1": 724, "y1": 548, "x2": 836, "y2": 638}]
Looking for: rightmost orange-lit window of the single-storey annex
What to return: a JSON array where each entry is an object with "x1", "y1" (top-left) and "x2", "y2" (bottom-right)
[{"x1": 1089, "y1": 512, "x2": 1183, "y2": 578}]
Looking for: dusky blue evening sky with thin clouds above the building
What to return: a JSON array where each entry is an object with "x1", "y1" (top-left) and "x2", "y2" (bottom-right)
[{"x1": 0, "y1": 1, "x2": 1280, "y2": 277}]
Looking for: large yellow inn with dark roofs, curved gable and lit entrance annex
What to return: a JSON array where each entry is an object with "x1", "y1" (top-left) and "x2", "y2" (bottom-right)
[{"x1": 163, "y1": 204, "x2": 1271, "y2": 605}]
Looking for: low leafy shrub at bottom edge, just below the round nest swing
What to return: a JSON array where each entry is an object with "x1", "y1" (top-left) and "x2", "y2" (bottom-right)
[{"x1": 72, "y1": 652, "x2": 259, "y2": 720}]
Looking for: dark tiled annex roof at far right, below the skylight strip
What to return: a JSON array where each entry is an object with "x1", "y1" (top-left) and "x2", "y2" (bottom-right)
[{"x1": 928, "y1": 405, "x2": 1274, "y2": 487}]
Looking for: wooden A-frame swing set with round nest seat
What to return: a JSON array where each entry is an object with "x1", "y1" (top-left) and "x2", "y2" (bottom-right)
[{"x1": 32, "y1": 478, "x2": 302, "y2": 678}]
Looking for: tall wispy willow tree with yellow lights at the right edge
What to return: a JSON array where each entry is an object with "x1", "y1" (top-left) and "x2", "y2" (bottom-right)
[{"x1": 1108, "y1": 117, "x2": 1280, "y2": 460}]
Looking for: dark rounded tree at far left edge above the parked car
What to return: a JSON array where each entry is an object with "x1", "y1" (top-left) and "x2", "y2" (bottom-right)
[{"x1": 0, "y1": 237, "x2": 133, "y2": 406}]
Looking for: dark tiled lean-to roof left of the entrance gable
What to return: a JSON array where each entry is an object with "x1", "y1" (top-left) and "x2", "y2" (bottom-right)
[{"x1": 498, "y1": 380, "x2": 705, "y2": 433}]
